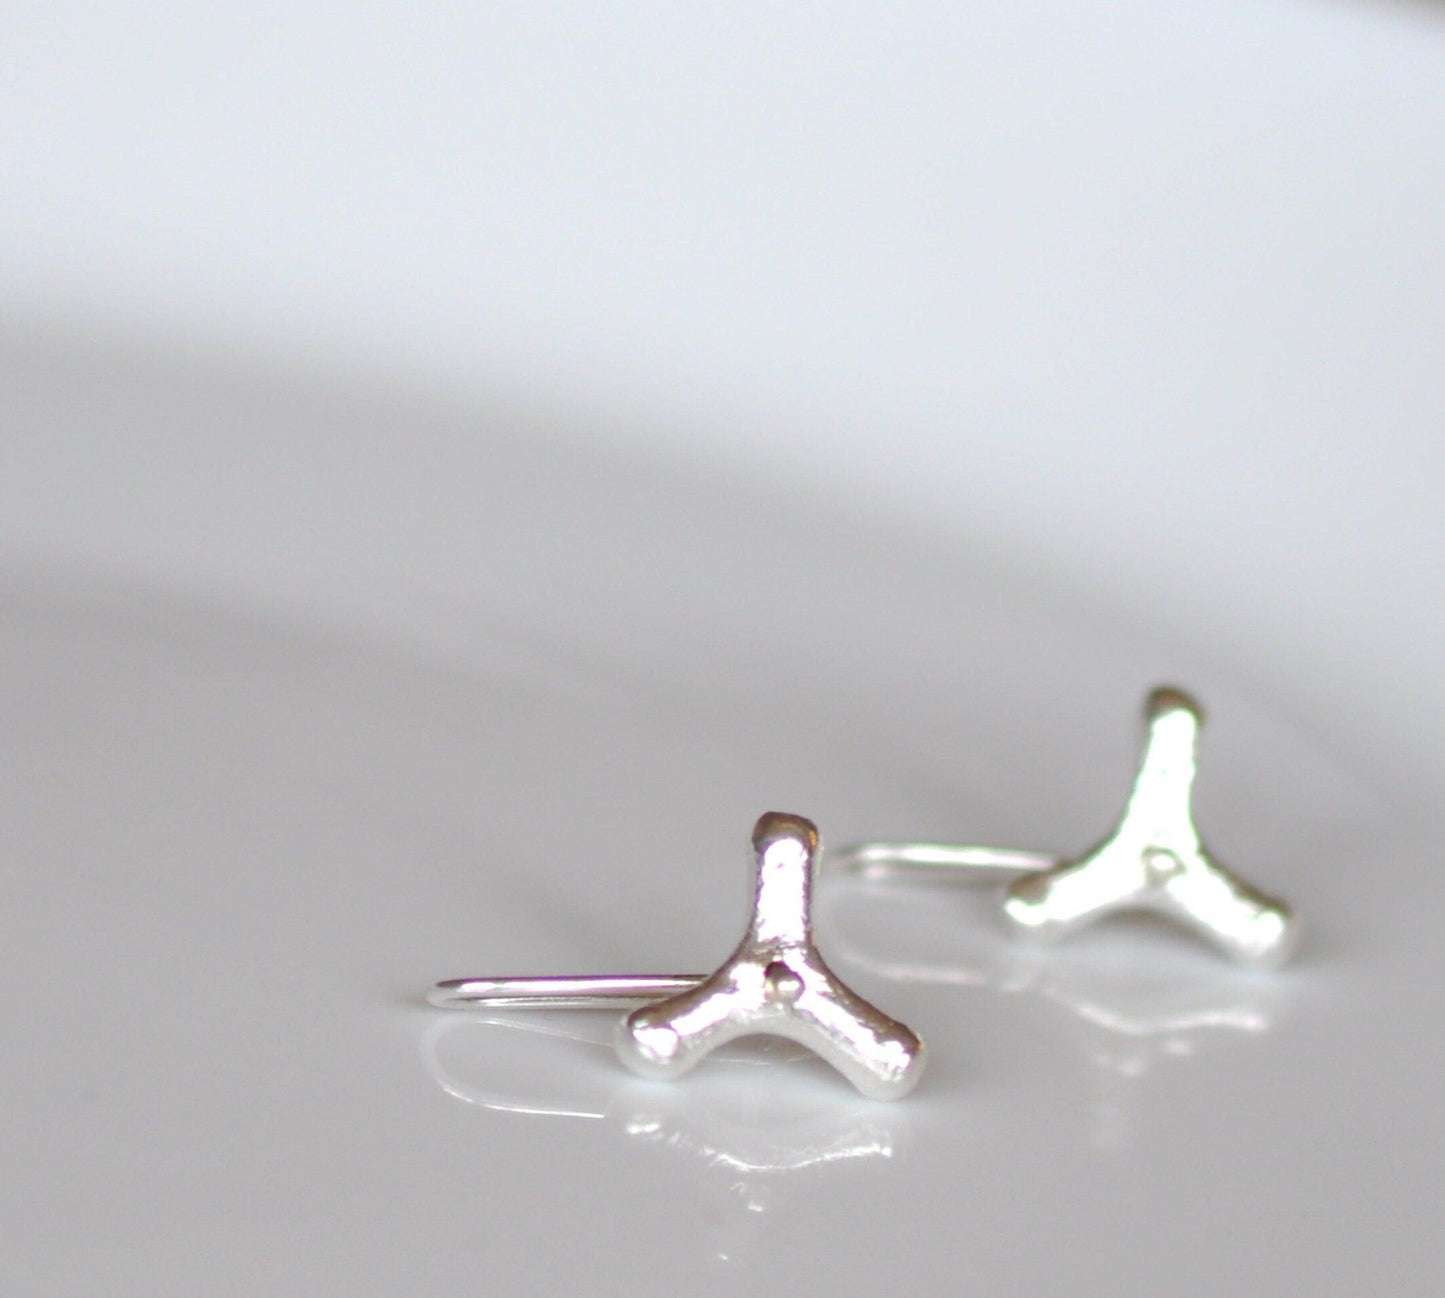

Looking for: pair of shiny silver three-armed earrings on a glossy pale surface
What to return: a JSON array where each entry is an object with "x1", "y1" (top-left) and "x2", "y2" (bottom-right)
[{"x1": 428, "y1": 689, "x2": 1298, "y2": 1100}]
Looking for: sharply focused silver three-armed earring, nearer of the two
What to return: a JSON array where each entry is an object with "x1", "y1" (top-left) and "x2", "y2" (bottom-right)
[{"x1": 428, "y1": 812, "x2": 923, "y2": 1100}]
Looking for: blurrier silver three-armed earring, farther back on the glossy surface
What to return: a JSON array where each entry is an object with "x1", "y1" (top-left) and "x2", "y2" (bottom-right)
[{"x1": 834, "y1": 689, "x2": 1298, "y2": 966}]
